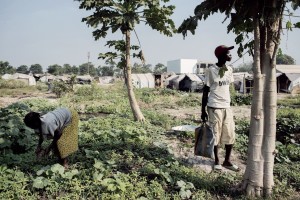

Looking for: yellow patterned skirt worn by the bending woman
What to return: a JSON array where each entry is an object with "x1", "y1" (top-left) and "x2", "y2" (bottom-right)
[{"x1": 57, "y1": 109, "x2": 79, "y2": 158}]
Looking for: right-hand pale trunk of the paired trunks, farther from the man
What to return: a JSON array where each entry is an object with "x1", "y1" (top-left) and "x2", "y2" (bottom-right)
[{"x1": 262, "y1": 6, "x2": 281, "y2": 196}]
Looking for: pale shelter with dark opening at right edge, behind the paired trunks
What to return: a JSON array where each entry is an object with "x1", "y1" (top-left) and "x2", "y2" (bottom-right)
[{"x1": 276, "y1": 65, "x2": 300, "y2": 94}]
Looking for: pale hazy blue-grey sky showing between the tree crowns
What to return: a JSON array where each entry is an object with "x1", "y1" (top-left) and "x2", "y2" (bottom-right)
[{"x1": 0, "y1": 0, "x2": 300, "y2": 69}]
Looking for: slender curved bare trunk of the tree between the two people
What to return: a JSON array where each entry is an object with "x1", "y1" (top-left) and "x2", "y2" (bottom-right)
[{"x1": 125, "y1": 30, "x2": 145, "y2": 122}]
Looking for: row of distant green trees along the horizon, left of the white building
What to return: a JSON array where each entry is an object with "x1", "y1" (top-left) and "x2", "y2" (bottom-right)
[{"x1": 0, "y1": 61, "x2": 167, "y2": 76}]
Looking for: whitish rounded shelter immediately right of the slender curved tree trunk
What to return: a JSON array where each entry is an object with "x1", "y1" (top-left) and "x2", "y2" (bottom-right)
[{"x1": 131, "y1": 73, "x2": 155, "y2": 88}]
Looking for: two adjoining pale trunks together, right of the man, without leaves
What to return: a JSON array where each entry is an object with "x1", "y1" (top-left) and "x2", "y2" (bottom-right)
[{"x1": 243, "y1": 0, "x2": 283, "y2": 197}]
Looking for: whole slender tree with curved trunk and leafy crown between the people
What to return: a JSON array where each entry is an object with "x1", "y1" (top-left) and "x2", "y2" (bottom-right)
[{"x1": 79, "y1": 0, "x2": 175, "y2": 121}]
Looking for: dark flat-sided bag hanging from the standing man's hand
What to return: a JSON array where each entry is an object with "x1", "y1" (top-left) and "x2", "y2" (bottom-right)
[{"x1": 194, "y1": 123, "x2": 215, "y2": 158}]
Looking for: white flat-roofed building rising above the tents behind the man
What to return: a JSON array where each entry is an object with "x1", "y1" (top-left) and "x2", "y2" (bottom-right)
[{"x1": 167, "y1": 59, "x2": 213, "y2": 74}]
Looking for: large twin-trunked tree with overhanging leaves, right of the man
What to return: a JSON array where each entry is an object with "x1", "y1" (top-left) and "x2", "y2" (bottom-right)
[{"x1": 179, "y1": 0, "x2": 300, "y2": 196}]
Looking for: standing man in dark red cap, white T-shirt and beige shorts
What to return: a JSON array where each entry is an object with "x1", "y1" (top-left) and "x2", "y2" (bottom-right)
[{"x1": 201, "y1": 45, "x2": 240, "y2": 171}]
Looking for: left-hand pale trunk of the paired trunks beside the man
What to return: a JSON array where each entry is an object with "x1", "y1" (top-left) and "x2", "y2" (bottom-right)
[{"x1": 243, "y1": 15, "x2": 264, "y2": 196}]
